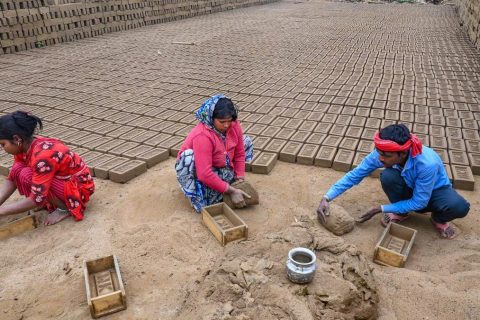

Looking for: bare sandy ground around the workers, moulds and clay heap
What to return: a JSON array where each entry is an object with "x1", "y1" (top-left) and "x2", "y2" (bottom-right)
[{"x1": 0, "y1": 159, "x2": 480, "y2": 320}]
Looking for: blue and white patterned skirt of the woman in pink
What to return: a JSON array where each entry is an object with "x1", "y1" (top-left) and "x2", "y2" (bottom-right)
[{"x1": 175, "y1": 135, "x2": 253, "y2": 213}]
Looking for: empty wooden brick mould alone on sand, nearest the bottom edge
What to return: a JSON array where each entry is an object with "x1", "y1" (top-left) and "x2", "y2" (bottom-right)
[{"x1": 83, "y1": 255, "x2": 127, "y2": 318}]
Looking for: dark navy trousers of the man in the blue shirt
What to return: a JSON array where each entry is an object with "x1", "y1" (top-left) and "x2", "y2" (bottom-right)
[{"x1": 380, "y1": 168, "x2": 470, "y2": 223}]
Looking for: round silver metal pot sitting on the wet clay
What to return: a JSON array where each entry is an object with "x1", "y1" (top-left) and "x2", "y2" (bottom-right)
[{"x1": 287, "y1": 248, "x2": 317, "y2": 284}]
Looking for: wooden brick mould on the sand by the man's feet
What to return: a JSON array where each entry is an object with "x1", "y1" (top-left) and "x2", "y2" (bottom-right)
[{"x1": 373, "y1": 223, "x2": 417, "y2": 267}]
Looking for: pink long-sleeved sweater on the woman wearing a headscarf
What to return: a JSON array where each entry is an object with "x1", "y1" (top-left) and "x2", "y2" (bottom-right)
[{"x1": 177, "y1": 121, "x2": 245, "y2": 193}]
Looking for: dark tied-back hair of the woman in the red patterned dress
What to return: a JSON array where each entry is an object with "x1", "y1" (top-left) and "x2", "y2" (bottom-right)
[{"x1": 0, "y1": 111, "x2": 43, "y2": 140}]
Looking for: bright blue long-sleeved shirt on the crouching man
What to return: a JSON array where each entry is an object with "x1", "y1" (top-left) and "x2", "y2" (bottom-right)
[{"x1": 325, "y1": 146, "x2": 451, "y2": 214}]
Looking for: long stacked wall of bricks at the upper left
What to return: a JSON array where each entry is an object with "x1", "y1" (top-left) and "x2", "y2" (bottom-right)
[{"x1": 0, "y1": 0, "x2": 276, "y2": 54}]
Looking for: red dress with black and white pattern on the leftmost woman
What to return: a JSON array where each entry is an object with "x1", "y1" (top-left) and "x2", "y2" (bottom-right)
[{"x1": 8, "y1": 137, "x2": 95, "y2": 221}]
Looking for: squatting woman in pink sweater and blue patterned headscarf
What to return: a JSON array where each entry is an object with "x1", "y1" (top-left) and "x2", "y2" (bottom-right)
[{"x1": 175, "y1": 94, "x2": 253, "y2": 212}]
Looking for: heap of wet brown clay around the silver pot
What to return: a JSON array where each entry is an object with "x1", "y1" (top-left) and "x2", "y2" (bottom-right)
[{"x1": 178, "y1": 217, "x2": 378, "y2": 320}]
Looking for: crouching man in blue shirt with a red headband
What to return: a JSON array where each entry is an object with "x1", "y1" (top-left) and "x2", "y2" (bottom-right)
[{"x1": 317, "y1": 124, "x2": 470, "y2": 239}]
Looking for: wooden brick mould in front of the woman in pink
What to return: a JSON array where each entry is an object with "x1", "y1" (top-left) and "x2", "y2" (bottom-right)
[{"x1": 202, "y1": 202, "x2": 248, "y2": 246}]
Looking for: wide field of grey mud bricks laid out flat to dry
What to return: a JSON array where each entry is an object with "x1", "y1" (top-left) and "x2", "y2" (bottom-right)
[{"x1": 0, "y1": 1, "x2": 480, "y2": 189}]
